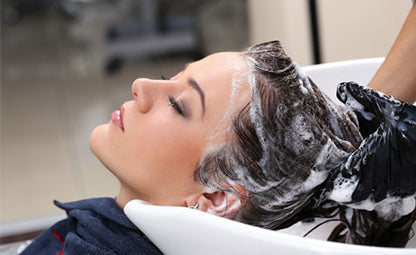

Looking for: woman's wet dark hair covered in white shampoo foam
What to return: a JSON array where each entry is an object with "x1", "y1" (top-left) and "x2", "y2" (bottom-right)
[{"x1": 195, "y1": 41, "x2": 411, "y2": 246}]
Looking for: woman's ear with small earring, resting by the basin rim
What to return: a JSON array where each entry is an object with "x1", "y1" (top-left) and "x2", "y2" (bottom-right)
[{"x1": 186, "y1": 184, "x2": 246, "y2": 217}]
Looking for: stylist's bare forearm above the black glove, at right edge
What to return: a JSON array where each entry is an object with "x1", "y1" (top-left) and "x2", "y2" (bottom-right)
[{"x1": 368, "y1": 4, "x2": 416, "y2": 103}]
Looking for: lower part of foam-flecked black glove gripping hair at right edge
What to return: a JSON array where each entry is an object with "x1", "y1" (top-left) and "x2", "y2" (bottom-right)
[{"x1": 335, "y1": 117, "x2": 416, "y2": 202}]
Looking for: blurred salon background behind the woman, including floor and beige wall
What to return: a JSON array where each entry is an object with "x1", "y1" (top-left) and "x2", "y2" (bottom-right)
[{"x1": 0, "y1": 0, "x2": 411, "y2": 243}]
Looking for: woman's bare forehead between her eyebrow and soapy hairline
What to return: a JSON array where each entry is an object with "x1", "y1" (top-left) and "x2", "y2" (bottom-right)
[{"x1": 188, "y1": 52, "x2": 250, "y2": 137}]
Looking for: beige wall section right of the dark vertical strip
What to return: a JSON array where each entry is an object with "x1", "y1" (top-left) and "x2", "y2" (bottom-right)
[{"x1": 318, "y1": 0, "x2": 411, "y2": 62}]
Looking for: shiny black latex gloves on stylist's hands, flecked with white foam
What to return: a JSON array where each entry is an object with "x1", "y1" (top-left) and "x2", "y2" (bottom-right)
[{"x1": 327, "y1": 82, "x2": 416, "y2": 202}]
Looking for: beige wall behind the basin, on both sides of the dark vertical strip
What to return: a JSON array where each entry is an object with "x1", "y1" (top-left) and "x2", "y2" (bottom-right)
[{"x1": 248, "y1": 0, "x2": 411, "y2": 65}]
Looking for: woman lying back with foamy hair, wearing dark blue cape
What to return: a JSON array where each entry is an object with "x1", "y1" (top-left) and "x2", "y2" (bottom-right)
[{"x1": 22, "y1": 41, "x2": 414, "y2": 254}]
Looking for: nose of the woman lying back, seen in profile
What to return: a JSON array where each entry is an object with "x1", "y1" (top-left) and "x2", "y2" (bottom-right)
[{"x1": 131, "y1": 78, "x2": 175, "y2": 113}]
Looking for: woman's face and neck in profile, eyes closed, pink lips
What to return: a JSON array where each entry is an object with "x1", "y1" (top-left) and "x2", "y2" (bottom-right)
[{"x1": 90, "y1": 52, "x2": 249, "y2": 206}]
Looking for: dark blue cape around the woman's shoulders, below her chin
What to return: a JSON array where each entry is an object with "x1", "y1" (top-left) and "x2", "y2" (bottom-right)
[{"x1": 21, "y1": 198, "x2": 162, "y2": 255}]
